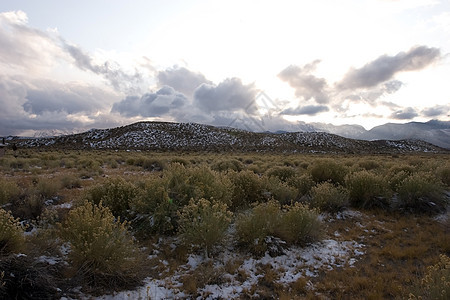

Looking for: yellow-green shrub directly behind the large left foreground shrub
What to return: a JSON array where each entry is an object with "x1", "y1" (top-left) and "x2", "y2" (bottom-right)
[{"x1": 85, "y1": 177, "x2": 137, "y2": 217}]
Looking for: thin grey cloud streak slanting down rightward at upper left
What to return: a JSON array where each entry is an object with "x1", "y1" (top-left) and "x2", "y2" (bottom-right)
[{"x1": 61, "y1": 39, "x2": 143, "y2": 94}]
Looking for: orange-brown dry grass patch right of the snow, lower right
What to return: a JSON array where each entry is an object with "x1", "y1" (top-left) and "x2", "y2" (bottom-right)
[{"x1": 308, "y1": 212, "x2": 449, "y2": 299}]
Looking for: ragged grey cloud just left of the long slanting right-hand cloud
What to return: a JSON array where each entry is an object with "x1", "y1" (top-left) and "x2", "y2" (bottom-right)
[{"x1": 278, "y1": 60, "x2": 329, "y2": 104}]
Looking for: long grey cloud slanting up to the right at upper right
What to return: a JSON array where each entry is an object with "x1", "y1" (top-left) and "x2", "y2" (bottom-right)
[{"x1": 337, "y1": 46, "x2": 441, "y2": 90}]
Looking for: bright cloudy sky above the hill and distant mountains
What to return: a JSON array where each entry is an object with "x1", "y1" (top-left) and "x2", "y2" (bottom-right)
[{"x1": 0, "y1": 0, "x2": 450, "y2": 136}]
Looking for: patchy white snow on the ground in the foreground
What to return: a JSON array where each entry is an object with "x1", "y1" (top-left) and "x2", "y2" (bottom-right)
[{"x1": 97, "y1": 239, "x2": 364, "y2": 300}]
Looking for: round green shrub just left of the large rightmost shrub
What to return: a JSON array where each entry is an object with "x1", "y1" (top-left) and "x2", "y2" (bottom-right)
[{"x1": 345, "y1": 171, "x2": 392, "y2": 208}]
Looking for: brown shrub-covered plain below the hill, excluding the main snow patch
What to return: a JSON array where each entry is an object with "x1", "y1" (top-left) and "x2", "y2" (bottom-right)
[{"x1": 0, "y1": 149, "x2": 450, "y2": 299}]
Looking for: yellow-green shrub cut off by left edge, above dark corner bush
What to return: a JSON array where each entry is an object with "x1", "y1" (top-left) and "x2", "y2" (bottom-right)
[{"x1": 0, "y1": 208, "x2": 25, "y2": 255}]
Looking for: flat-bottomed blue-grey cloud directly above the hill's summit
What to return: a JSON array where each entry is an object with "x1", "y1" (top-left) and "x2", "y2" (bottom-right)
[{"x1": 111, "y1": 86, "x2": 188, "y2": 117}]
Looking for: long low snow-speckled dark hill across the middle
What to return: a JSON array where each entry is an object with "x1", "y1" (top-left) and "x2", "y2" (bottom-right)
[{"x1": 13, "y1": 122, "x2": 445, "y2": 154}]
